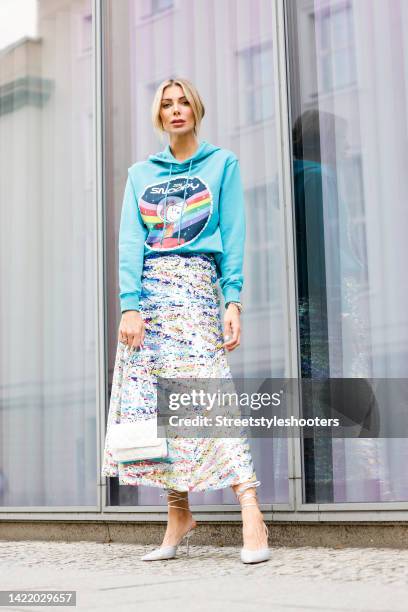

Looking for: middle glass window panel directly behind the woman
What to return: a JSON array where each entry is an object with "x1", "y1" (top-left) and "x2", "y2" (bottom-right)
[{"x1": 104, "y1": 0, "x2": 289, "y2": 505}]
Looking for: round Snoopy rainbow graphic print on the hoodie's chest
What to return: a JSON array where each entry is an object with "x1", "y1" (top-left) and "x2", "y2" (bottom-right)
[{"x1": 138, "y1": 175, "x2": 213, "y2": 251}]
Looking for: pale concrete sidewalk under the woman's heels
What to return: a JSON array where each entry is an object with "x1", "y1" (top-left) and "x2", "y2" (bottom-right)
[{"x1": 0, "y1": 538, "x2": 408, "y2": 612}]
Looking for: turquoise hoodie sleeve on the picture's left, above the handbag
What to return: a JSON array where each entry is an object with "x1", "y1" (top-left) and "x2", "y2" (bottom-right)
[{"x1": 119, "y1": 170, "x2": 147, "y2": 312}]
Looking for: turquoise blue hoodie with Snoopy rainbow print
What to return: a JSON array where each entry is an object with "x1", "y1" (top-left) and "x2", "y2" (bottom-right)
[{"x1": 119, "y1": 140, "x2": 245, "y2": 312}]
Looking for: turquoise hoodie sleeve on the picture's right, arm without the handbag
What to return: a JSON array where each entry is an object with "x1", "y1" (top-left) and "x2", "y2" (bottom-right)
[{"x1": 215, "y1": 158, "x2": 246, "y2": 303}]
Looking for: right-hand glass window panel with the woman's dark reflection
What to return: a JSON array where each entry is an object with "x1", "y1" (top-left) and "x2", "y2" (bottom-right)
[{"x1": 288, "y1": 0, "x2": 408, "y2": 502}]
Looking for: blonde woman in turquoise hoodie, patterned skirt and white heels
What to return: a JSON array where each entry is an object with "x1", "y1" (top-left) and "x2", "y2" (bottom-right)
[{"x1": 102, "y1": 79, "x2": 269, "y2": 563}]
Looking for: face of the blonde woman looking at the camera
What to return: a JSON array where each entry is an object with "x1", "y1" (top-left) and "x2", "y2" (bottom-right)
[{"x1": 160, "y1": 85, "x2": 195, "y2": 134}]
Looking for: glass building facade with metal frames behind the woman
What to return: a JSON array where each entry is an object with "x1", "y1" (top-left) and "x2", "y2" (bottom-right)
[{"x1": 0, "y1": 0, "x2": 408, "y2": 521}]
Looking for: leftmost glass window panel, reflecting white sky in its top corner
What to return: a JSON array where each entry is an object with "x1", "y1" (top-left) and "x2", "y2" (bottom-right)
[{"x1": 0, "y1": 0, "x2": 99, "y2": 508}]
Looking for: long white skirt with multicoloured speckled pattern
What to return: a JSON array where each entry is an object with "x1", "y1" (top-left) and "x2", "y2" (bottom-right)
[{"x1": 102, "y1": 253, "x2": 256, "y2": 491}]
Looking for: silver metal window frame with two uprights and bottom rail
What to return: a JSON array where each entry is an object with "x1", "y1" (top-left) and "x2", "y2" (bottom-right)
[{"x1": 0, "y1": 0, "x2": 408, "y2": 523}]
